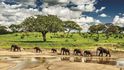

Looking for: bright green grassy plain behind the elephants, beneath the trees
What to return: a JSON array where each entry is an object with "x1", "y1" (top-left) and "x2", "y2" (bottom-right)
[{"x1": 0, "y1": 32, "x2": 124, "y2": 49}]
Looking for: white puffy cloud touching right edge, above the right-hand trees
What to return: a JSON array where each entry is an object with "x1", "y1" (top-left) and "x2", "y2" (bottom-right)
[{"x1": 113, "y1": 15, "x2": 124, "y2": 27}]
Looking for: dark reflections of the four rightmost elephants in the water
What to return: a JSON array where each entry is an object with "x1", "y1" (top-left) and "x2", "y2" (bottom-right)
[{"x1": 61, "y1": 57, "x2": 116, "y2": 65}]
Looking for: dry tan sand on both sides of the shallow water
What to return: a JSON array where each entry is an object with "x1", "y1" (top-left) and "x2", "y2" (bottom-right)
[{"x1": 0, "y1": 49, "x2": 124, "y2": 70}]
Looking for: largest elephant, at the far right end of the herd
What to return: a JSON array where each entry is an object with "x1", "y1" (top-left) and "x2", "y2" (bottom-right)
[{"x1": 96, "y1": 47, "x2": 111, "y2": 57}]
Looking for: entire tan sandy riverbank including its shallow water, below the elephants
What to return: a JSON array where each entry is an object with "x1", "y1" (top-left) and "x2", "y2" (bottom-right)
[{"x1": 0, "y1": 50, "x2": 124, "y2": 70}]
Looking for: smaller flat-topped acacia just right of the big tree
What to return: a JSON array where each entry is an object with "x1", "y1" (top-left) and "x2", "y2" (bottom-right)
[{"x1": 64, "y1": 21, "x2": 82, "y2": 37}]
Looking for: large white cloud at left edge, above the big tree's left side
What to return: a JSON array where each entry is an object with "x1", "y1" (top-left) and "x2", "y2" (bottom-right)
[{"x1": 0, "y1": 3, "x2": 42, "y2": 25}]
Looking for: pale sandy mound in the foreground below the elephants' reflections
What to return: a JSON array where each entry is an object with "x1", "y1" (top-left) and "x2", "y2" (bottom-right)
[{"x1": 24, "y1": 61, "x2": 118, "y2": 70}]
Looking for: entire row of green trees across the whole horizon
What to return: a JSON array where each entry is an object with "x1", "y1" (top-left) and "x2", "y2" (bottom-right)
[{"x1": 0, "y1": 15, "x2": 124, "y2": 41}]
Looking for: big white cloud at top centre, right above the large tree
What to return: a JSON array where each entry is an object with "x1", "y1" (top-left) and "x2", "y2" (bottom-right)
[{"x1": 42, "y1": 0, "x2": 95, "y2": 20}]
